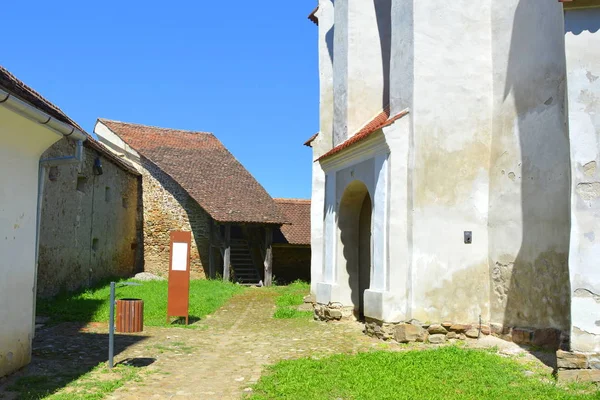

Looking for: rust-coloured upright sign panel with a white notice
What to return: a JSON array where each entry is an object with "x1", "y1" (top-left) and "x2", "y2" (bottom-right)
[{"x1": 167, "y1": 232, "x2": 192, "y2": 325}]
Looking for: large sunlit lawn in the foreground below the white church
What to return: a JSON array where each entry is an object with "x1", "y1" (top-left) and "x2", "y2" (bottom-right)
[{"x1": 250, "y1": 346, "x2": 599, "y2": 400}]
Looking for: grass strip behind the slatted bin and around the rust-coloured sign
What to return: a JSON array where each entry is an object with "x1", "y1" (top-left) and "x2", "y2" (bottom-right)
[{"x1": 37, "y1": 280, "x2": 244, "y2": 327}]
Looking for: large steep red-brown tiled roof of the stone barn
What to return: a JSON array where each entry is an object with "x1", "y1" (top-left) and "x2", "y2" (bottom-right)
[{"x1": 98, "y1": 119, "x2": 286, "y2": 224}]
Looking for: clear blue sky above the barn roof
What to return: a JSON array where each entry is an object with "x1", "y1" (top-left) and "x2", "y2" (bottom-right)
[{"x1": 0, "y1": 0, "x2": 319, "y2": 198}]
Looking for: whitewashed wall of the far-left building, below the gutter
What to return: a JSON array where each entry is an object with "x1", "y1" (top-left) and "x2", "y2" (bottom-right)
[{"x1": 0, "y1": 106, "x2": 61, "y2": 377}]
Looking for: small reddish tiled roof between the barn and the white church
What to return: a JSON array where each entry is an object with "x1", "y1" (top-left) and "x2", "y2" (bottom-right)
[{"x1": 274, "y1": 199, "x2": 310, "y2": 245}]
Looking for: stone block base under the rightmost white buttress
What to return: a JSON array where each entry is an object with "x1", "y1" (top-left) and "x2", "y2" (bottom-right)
[{"x1": 556, "y1": 350, "x2": 600, "y2": 382}]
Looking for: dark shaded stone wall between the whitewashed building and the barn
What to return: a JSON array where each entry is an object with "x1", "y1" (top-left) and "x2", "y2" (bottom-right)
[{"x1": 37, "y1": 139, "x2": 142, "y2": 297}]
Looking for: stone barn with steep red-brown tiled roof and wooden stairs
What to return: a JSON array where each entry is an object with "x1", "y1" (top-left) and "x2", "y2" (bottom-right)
[{"x1": 95, "y1": 119, "x2": 288, "y2": 284}]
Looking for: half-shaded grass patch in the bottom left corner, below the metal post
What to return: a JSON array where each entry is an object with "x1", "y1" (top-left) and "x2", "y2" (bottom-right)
[{"x1": 8, "y1": 363, "x2": 140, "y2": 400}]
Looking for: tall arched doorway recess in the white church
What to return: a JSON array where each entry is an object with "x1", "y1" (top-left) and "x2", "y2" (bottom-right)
[{"x1": 338, "y1": 181, "x2": 373, "y2": 317}]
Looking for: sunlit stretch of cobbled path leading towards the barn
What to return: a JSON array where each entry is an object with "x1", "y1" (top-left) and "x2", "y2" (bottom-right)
[{"x1": 108, "y1": 289, "x2": 379, "y2": 399}]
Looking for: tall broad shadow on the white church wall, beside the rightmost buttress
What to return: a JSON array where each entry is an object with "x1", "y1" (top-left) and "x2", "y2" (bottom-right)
[{"x1": 491, "y1": 0, "x2": 570, "y2": 330}]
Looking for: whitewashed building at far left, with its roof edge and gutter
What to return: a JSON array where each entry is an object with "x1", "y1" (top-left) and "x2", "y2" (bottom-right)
[{"x1": 0, "y1": 67, "x2": 86, "y2": 377}]
